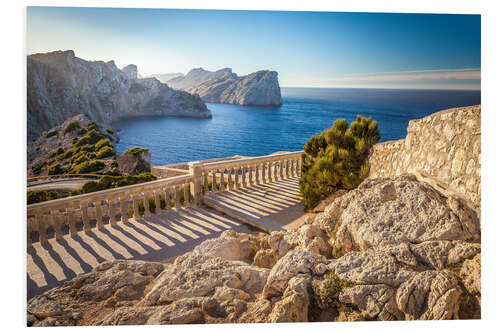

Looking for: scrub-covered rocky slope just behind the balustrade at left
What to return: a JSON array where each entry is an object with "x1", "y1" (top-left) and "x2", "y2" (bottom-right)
[{"x1": 27, "y1": 119, "x2": 156, "y2": 204}]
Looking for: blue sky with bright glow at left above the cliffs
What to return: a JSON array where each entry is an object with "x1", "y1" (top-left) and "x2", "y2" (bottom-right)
[{"x1": 27, "y1": 7, "x2": 481, "y2": 89}]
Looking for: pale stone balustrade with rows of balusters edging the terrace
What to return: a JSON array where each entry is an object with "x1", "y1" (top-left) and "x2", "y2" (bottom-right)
[{"x1": 27, "y1": 151, "x2": 302, "y2": 246}]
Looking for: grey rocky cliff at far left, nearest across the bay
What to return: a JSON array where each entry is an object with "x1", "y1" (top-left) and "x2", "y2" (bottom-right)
[{"x1": 27, "y1": 51, "x2": 211, "y2": 140}]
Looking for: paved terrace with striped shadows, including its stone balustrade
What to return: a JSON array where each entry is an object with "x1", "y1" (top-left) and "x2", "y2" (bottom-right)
[{"x1": 27, "y1": 153, "x2": 305, "y2": 299}]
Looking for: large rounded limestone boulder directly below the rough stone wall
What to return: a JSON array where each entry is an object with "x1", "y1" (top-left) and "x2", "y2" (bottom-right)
[{"x1": 328, "y1": 176, "x2": 479, "y2": 253}]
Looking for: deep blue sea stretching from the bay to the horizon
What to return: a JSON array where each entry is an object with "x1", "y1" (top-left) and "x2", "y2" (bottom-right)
[{"x1": 115, "y1": 88, "x2": 481, "y2": 165}]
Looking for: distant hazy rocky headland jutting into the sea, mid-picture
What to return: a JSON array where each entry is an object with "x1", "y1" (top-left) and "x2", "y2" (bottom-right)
[{"x1": 167, "y1": 68, "x2": 282, "y2": 106}]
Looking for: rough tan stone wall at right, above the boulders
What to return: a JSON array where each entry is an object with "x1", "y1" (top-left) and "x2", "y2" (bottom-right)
[{"x1": 369, "y1": 105, "x2": 481, "y2": 212}]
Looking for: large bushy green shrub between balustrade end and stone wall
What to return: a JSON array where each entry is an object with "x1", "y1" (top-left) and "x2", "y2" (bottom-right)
[{"x1": 300, "y1": 116, "x2": 380, "y2": 208}]
